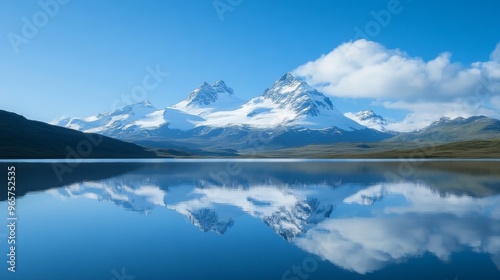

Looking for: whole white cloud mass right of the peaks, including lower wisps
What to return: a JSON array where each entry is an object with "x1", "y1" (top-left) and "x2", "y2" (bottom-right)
[{"x1": 293, "y1": 39, "x2": 500, "y2": 129}]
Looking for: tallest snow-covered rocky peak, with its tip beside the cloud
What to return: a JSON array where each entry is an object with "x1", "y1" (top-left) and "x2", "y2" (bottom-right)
[{"x1": 199, "y1": 73, "x2": 365, "y2": 131}]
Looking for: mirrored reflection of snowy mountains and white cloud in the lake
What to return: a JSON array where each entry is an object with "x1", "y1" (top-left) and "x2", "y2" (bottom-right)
[{"x1": 42, "y1": 162, "x2": 500, "y2": 274}]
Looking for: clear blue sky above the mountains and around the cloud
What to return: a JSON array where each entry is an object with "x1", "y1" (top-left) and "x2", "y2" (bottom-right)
[{"x1": 0, "y1": 0, "x2": 500, "y2": 127}]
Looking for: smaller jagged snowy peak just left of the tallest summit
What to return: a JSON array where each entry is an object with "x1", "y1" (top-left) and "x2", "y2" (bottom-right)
[{"x1": 171, "y1": 81, "x2": 245, "y2": 117}]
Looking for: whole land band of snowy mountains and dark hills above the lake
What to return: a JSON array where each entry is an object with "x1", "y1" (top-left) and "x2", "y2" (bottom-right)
[{"x1": 0, "y1": 73, "x2": 500, "y2": 158}]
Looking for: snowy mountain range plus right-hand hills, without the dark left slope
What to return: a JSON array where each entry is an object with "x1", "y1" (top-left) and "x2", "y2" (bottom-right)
[{"x1": 53, "y1": 73, "x2": 500, "y2": 152}]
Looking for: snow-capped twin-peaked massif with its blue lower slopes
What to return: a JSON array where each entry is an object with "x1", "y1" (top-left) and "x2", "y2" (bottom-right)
[{"x1": 57, "y1": 73, "x2": 390, "y2": 150}]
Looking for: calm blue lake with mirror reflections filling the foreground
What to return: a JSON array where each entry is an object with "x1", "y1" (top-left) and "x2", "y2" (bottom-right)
[{"x1": 0, "y1": 160, "x2": 500, "y2": 280}]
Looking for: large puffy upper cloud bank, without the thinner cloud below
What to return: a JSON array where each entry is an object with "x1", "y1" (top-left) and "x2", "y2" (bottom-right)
[{"x1": 294, "y1": 39, "x2": 500, "y2": 100}]
